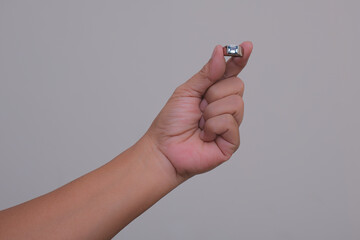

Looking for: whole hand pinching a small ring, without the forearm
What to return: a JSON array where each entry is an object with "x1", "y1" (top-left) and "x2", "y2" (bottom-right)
[{"x1": 145, "y1": 42, "x2": 252, "y2": 178}]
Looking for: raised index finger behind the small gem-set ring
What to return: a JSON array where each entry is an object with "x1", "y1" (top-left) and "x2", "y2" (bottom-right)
[{"x1": 223, "y1": 41, "x2": 253, "y2": 79}]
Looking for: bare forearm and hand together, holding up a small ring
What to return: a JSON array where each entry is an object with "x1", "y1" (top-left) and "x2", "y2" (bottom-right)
[{"x1": 0, "y1": 42, "x2": 252, "y2": 239}]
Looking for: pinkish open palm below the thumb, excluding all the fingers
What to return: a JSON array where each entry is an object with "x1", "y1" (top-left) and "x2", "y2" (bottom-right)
[{"x1": 148, "y1": 92, "x2": 226, "y2": 176}]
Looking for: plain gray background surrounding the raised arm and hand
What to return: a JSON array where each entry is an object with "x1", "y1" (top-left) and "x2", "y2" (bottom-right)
[{"x1": 0, "y1": 0, "x2": 360, "y2": 240}]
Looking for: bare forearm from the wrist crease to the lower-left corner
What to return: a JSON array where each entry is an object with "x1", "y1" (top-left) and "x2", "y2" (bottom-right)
[{"x1": 0, "y1": 137, "x2": 182, "y2": 239}]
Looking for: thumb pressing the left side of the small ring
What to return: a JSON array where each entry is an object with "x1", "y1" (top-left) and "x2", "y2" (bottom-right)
[{"x1": 182, "y1": 45, "x2": 226, "y2": 97}]
